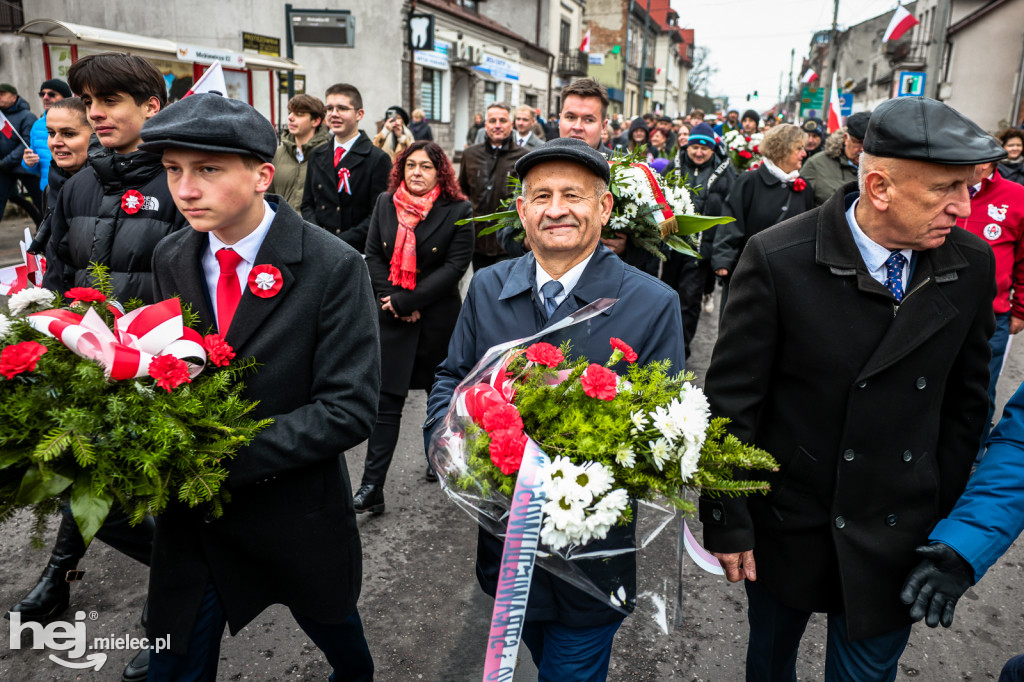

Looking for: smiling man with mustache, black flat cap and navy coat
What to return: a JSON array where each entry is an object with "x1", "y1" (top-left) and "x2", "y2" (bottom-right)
[{"x1": 423, "y1": 137, "x2": 684, "y2": 682}]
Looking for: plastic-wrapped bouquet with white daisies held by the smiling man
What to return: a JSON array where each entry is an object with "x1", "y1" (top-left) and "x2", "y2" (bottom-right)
[{"x1": 429, "y1": 299, "x2": 776, "y2": 633}]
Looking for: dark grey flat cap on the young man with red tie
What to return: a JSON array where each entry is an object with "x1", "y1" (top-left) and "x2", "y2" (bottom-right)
[{"x1": 138, "y1": 92, "x2": 278, "y2": 163}]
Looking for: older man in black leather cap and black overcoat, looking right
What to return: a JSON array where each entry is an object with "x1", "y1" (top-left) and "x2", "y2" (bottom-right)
[{"x1": 700, "y1": 97, "x2": 1005, "y2": 680}]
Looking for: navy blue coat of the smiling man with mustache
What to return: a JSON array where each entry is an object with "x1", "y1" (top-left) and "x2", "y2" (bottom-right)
[{"x1": 424, "y1": 245, "x2": 684, "y2": 628}]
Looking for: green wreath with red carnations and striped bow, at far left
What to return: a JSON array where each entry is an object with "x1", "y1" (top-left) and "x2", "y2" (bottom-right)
[{"x1": 0, "y1": 266, "x2": 269, "y2": 543}]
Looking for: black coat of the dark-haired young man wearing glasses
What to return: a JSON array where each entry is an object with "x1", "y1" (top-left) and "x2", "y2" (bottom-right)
[{"x1": 302, "y1": 130, "x2": 391, "y2": 253}]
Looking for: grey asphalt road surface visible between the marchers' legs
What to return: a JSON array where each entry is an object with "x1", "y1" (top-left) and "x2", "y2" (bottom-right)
[{"x1": 0, "y1": 251, "x2": 1024, "y2": 682}]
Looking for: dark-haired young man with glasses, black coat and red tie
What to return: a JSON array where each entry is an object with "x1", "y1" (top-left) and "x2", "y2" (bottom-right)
[{"x1": 302, "y1": 83, "x2": 391, "y2": 253}]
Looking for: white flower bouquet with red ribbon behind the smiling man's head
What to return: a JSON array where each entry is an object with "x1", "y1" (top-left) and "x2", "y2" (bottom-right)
[{"x1": 456, "y1": 145, "x2": 733, "y2": 260}]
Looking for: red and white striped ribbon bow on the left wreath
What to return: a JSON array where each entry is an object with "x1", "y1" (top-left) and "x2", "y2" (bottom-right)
[{"x1": 28, "y1": 298, "x2": 206, "y2": 381}]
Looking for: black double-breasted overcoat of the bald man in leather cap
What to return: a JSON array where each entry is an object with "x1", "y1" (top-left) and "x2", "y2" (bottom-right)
[{"x1": 700, "y1": 183, "x2": 995, "y2": 639}]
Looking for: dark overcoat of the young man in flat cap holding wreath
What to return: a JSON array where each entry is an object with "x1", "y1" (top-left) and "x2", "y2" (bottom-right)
[{"x1": 148, "y1": 195, "x2": 380, "y2": 653}]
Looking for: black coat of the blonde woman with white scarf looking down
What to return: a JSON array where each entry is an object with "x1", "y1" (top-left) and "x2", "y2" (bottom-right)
[{"x1": 711, "y1": 165, "x2": 814, "y2": 274}]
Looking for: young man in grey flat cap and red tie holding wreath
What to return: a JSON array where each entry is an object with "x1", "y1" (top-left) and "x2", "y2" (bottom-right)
[{"x1": 141, "y1": 94, "x2": 380, "y2": 681}]
